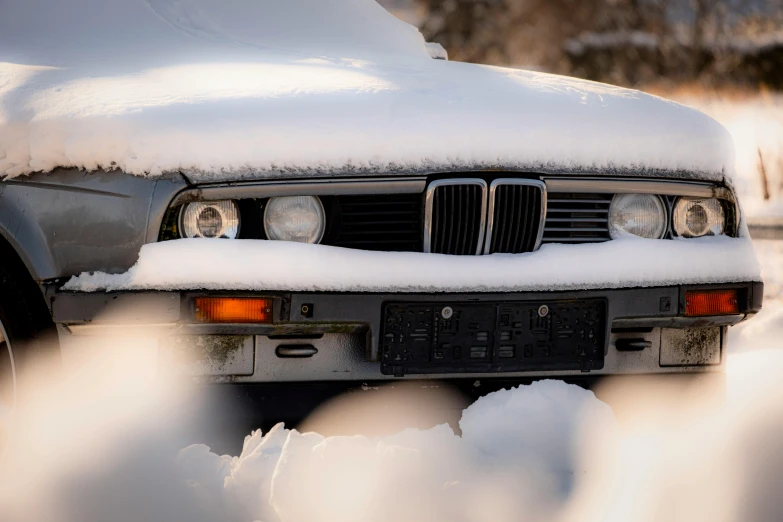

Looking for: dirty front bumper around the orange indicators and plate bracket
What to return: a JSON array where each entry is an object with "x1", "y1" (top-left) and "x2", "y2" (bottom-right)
[{"x1": 52, "y1": 282, "x2": 763, "y2": 383}]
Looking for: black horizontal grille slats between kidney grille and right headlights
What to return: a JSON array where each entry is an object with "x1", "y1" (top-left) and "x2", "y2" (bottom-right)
[{"x1": 542, "y1": 193, "x2": 613, "y2": 243}]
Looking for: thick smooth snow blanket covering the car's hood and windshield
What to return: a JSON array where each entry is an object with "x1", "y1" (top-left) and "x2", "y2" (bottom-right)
[{"x1": 0, "y1": 0, "x2": 733, "y2": 182}]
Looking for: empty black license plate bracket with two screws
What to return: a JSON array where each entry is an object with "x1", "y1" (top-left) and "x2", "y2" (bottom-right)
[{"x1": 381, "y1": 299, "x2": 606, "y2": 376}]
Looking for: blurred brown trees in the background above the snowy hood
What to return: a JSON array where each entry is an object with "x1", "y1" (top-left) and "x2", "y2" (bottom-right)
[{"x1": 380, "y1": 0, "x2": 783, "y2": 89}]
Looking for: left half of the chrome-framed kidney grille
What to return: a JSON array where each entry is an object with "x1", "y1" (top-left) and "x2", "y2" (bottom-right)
[{"x1": 424, "y1": 178, "x2": 487, "y2": 255}]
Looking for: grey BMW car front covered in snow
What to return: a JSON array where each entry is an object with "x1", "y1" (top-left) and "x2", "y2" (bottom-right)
[{"x1": 0, "y1": 0, "x2": 762, "y2": 428}]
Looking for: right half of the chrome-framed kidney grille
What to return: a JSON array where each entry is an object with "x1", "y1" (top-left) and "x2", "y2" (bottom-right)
[{"x1": 484, "y1": 179, "x2": 546, "y2": 254}]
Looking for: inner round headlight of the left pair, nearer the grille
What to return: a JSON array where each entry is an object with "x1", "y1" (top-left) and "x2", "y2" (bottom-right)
[{"x1": 264, "y1": 196, "x2": 326, "y2": 243}]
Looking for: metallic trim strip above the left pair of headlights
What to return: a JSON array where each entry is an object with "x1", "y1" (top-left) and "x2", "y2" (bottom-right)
[{"x1": 169, "y1": 177, "x2": 427, "y2": 207}]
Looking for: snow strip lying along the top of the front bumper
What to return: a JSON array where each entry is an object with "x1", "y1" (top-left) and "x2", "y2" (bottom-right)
[{"x1": 63, "y1": 237, "x2": 761, "y2": 292}]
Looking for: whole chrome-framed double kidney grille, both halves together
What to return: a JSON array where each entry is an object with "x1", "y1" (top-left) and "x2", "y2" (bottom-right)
[{"x1": 424, "y1": 178, "x2": 546, "y2": 255}]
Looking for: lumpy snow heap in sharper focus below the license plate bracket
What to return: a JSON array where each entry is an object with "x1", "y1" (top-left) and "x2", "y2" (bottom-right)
[{"x1": 178, "y1": 381, "x2": 617, "y2": 522}]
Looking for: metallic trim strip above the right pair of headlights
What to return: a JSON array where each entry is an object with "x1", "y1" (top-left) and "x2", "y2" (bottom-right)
[{"x1": 543, "y1": 176, "x2": 730, "y2": 199}]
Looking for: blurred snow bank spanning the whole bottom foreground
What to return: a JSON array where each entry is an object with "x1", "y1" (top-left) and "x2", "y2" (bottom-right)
[{"x1": 0, "y1": 324, "x2": 783, "y2": 522}]
